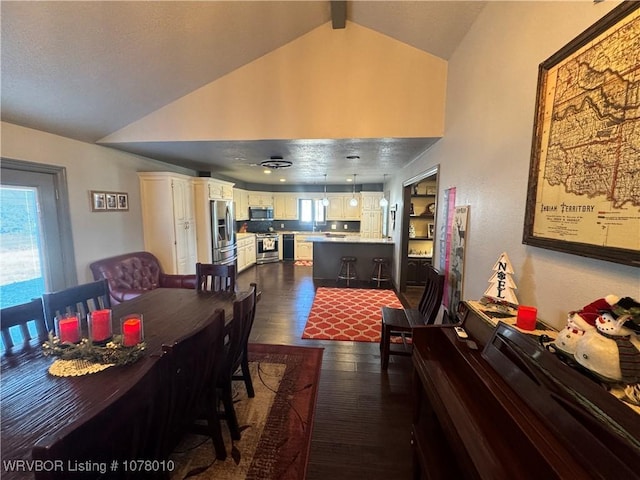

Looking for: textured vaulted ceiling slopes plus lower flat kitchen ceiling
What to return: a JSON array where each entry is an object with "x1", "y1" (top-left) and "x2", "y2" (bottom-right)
[{"x1": 0, "y1": 0, "x2": 485, "y2": 183}]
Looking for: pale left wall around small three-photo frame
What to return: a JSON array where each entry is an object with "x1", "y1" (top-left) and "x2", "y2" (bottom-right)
[{"x1": 0, "y1": 122, "x2": 195, "y2": 283}]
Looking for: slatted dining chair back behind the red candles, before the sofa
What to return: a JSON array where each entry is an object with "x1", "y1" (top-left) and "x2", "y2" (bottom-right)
[{"x1": 42, "y1": 279, "x2": 111, "y2": 331}]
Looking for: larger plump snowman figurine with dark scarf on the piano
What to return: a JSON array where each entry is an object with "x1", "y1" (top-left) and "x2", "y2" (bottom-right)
[{"x1": 574, "y1": 294, "x2": 640, "y2": 384}]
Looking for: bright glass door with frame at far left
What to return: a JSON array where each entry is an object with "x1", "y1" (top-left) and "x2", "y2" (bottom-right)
[{"x1": 0, "y1": 159, "x2": 77, "y2": 308}]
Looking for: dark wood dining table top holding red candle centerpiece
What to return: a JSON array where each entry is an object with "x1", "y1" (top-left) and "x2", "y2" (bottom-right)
[{"x1": 0, "y1": 288, "x2": 236, "y2": 479}]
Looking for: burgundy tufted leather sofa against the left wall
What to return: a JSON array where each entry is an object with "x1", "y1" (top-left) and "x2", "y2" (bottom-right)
[{"x1": 89, "y1": 252, "x2": 196, "y2": 304}]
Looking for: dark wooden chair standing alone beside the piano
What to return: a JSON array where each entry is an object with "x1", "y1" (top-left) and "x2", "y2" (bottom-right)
[{"x1": 380, "y1": 265, "x2": 444, "y2": 370}]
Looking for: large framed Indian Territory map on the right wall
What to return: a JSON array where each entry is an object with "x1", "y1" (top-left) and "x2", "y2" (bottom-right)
[{"x1": 523, "y1": 2, "x2": 640, "y2": 266}]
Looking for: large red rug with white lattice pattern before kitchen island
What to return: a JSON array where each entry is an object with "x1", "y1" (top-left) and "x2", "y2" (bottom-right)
[{"x1": 302, "y1": 287, "x2": 403, "y2": 342}]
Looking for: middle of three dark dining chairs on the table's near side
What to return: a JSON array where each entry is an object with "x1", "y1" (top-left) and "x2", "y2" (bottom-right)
[{"x1": 162, "y1": 309, "x2": 227, "y2": 460}]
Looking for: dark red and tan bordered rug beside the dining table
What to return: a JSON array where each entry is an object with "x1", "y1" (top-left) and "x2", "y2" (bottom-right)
[{"x1": 171, "y1": 343, "x2": 323, "y2": 480}]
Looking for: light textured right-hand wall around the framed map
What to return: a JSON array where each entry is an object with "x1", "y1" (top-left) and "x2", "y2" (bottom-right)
[{"x1": 390, "y1": 1, "x2": 640, "y2": 326}]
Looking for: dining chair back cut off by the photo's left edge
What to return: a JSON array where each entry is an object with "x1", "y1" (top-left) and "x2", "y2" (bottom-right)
[{"x1": 0, "y1": 298, "x2": 47, "y2": 352}]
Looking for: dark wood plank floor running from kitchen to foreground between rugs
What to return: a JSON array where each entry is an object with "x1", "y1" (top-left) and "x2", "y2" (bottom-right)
[{"x1": 238, "y1": 262, "x2": 411, "y2": 480}]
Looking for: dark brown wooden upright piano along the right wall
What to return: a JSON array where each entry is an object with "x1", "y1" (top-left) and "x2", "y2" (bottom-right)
[{"x1": 411, "y1": 302, "x2": 640, "y2": 480}]
